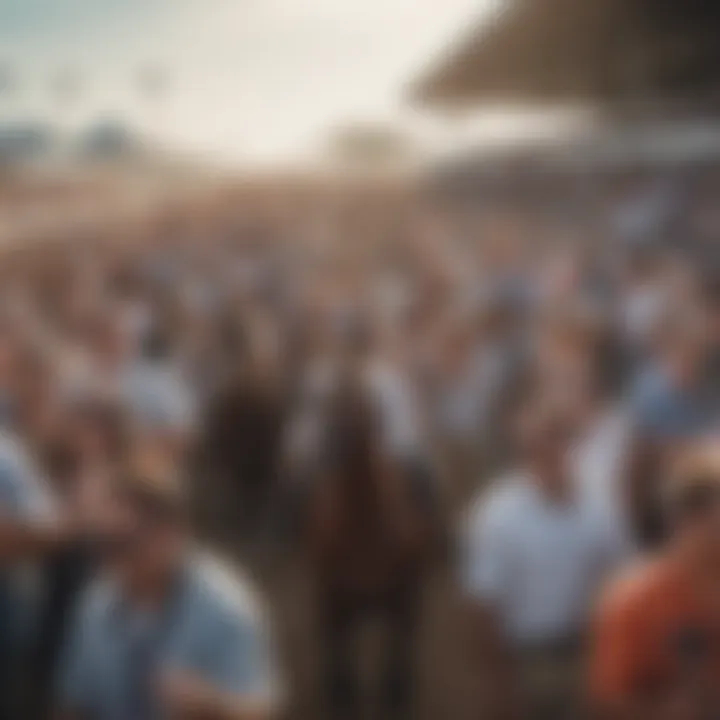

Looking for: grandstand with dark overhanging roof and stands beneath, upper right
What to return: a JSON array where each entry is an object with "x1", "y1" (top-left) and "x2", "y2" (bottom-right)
[{"x1": 410, "y1": 0, "x2": 720, "y2": 248}]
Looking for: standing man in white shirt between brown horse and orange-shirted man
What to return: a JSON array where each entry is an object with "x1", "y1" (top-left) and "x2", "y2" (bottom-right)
[{"x1": 463, "y1": 399, "x2": 616, "y2": 720}]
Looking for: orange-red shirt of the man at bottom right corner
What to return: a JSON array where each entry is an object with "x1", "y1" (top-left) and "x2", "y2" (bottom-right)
[{"x1": 591, "y1": 559, "x2": 720, "y2": 705}]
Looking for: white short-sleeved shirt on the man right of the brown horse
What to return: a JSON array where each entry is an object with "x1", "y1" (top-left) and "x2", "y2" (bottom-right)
[{"x1": 462, "y1": 473, "x2": 615, "y2": 646}]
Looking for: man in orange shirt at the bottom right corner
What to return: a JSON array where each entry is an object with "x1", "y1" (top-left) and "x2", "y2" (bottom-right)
[{"x1": 591, "y1": 445, "x2": 720, "y2": 720}]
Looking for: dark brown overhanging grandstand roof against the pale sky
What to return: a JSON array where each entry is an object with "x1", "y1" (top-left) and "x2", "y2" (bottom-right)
[{"x1": 410, "y1": 0, "x2": 720, "y2": 107}]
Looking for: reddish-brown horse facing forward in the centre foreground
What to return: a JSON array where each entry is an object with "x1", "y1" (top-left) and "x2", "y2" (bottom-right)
[{"x1": 306, "y1": 383, "x2": 438, "y2": 717}]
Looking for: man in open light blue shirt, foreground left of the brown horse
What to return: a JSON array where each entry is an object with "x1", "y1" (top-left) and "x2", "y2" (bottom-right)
[{"x1": 59, "y1": 452, "x2": 277, "y2": 720}]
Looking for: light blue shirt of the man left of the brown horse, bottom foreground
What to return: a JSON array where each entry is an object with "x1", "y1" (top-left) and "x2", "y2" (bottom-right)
[{"x1": 60, "y1": 556, "x2": 278, "y2": 720}]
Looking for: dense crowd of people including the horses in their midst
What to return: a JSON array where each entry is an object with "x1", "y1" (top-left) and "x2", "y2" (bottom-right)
[{"x1": 0, "y1": 170, "x2": 720, "y2": 720}]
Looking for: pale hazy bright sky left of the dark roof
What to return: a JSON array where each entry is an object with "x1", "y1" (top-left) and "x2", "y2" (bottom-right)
[{"x1": 0, "y1": 0, "x2": 497, "y2": 162}]
